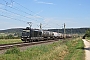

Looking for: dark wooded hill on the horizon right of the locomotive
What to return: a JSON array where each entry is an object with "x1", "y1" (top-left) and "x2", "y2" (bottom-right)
[{"x1": 48, "y1": 28, "x2": 90, "y2": 34}]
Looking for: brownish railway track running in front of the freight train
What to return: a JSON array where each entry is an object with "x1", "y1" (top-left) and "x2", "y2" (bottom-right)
[{"x1": 0, "y1": 39, "x2": 59, "y2": 50}]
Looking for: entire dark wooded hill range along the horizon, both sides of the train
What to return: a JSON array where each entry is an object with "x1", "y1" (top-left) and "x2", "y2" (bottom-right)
[{"x1": 0, "y1": 28, "x2": 90, "y2": 36}]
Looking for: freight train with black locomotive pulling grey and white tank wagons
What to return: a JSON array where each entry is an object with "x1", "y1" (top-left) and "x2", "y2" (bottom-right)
[{"x1": 21, "y1": 27, "x2": 72, "y2": 42}]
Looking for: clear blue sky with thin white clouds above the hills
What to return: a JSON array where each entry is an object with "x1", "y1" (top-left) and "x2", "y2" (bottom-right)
[{"x1": 0, "y1": 0, "x2": 90, "y2": 29}]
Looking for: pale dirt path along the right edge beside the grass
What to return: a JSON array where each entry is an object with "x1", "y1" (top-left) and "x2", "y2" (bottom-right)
[{"x1": 82, "y1": 39, "x2": 90, "y2": 60}]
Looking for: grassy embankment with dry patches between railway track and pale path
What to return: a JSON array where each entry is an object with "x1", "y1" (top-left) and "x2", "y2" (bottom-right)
[{"x1": 0, "y1": 39, "x2": 84, "y2": 60}]
